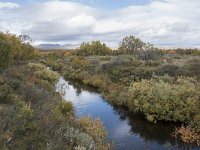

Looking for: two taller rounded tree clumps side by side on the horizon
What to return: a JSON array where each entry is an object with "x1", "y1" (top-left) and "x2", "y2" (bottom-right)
[{"x1": 73, "y1": 36, "x2": 159, "y2": 59}]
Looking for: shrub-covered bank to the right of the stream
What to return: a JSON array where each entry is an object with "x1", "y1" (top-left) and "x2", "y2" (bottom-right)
[{"x1": 45, "y1": 55, "x2": 200, "y2": 146}]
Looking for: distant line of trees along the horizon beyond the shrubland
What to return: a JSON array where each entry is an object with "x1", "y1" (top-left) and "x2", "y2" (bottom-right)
[{"x1": 44, "y1": 35, "x2": 200, "y2": 60}]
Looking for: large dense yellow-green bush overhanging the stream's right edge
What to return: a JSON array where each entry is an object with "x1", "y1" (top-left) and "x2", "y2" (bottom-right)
[{"x1": 128, "y1": 78, "x2": 200, "y2": 122}]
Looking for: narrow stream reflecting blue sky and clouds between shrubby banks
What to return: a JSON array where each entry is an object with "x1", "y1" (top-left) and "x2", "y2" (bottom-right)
[{"x1": 56, "y1": 78, "x2": 197, "y2": 150}]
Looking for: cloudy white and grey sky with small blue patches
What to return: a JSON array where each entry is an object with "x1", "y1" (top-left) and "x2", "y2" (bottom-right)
[{"x1": 0, "y1": 0, "x2": 200, "y2": 47}]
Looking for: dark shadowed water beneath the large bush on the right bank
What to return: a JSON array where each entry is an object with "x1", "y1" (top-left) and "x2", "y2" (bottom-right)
[{"x1": 113, "y1": 106, "x2": 177, "y2": 145}]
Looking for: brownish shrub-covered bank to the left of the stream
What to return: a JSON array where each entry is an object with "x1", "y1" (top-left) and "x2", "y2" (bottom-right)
[{"x1": 0, "y1": 63, "x2": 110, "y2": 150}]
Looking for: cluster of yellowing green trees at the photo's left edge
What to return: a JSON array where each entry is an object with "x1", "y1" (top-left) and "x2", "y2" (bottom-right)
[{"x1": 0, "y1": 32, "x2": 38, "y2": 69}]
